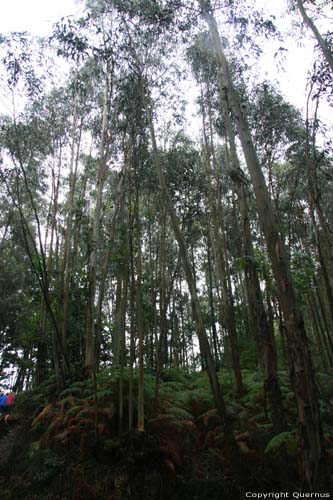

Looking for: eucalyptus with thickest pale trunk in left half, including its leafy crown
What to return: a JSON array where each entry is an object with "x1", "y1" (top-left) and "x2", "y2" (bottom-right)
[{"x1": 55, "y1": 6, "x2": 134, "y2": 371}]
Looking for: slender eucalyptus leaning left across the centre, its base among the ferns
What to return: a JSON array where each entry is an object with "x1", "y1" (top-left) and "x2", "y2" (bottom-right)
[{"x1": 113, "y1": 2, "x2": 241, "y2": 477}]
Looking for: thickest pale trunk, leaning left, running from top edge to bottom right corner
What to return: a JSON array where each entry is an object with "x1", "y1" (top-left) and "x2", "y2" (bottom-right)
[{"x1": 199, "y1": 0, "x2": 328, "y2": 491}]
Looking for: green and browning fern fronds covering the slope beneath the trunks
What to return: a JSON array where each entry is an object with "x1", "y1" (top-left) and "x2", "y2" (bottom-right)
[{"x1": 5, "y1": 369, "x2": 333, "y2": 494}]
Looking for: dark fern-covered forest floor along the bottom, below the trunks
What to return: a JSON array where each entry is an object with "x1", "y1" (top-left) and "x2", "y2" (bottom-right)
[{"x1": 0, "y1": 370, "x2": 333, "y2": 500}]
